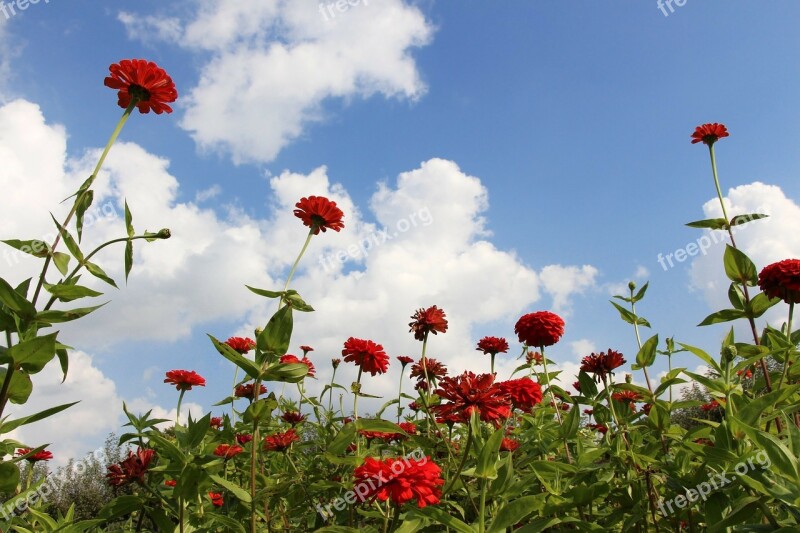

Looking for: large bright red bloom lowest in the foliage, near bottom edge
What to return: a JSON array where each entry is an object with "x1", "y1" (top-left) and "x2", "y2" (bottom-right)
[{"x1": 354, "y1": 457, "x2": 444, "y2": 508}]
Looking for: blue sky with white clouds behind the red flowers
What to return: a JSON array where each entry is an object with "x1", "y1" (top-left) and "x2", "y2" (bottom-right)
[{"x1": 0, "y1": 0, "x2": 800, "y2": 460}]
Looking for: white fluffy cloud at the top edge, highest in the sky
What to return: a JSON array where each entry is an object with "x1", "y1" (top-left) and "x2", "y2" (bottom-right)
[{"x1": 119, "y1": 0, "x2": 433, "y2": 163}]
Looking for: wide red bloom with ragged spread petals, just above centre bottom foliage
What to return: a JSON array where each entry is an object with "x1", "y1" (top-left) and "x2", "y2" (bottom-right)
[{"x1": 431, "y1": 372, "x2": 511, "y2": 423}]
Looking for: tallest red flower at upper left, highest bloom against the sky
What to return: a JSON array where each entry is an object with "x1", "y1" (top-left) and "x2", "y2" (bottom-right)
[{"x1": 104, "y1": 59, "x2": 178, "y2": 115}]
